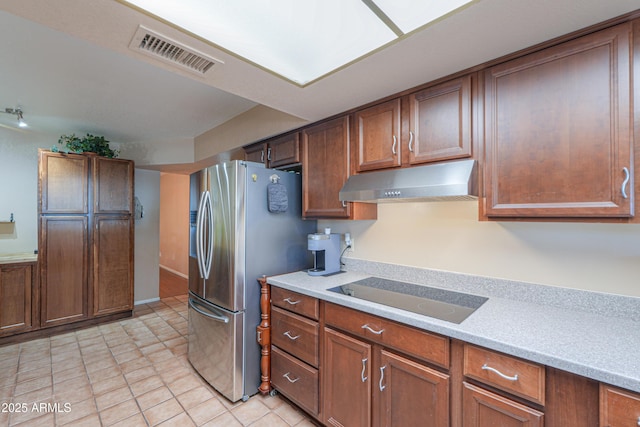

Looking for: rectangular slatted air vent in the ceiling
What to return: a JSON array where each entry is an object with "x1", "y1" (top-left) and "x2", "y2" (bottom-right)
[{"x1": 129, "y1": 25, "x2": 223, "y2": 75}]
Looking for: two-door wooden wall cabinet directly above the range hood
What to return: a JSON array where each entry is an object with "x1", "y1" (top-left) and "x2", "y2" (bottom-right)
[{"x1": 354, "y1": 75, "x2": 472, "y2": 172}]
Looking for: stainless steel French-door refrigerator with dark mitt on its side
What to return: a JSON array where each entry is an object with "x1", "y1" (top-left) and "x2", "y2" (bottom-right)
[{"x1": 188, "y1": 161, "x2": 316, "y2": 402}]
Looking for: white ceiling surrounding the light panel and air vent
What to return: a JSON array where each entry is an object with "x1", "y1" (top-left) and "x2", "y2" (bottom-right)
[{"x1": 0, "y1": 0, "x2": 640, "y2": 167}]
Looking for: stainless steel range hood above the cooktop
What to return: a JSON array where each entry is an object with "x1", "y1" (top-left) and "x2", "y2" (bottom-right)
[{"x1": 339, "y1": 160, "x2": 478, "y2": 203}]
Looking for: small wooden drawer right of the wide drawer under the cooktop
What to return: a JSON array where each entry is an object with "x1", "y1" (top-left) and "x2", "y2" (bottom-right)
[{"x1": 464, "y1": 344, "x2": 545, "y2": 405}]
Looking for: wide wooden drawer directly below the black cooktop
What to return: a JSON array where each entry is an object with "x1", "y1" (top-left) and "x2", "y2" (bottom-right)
[{"x1": 324, "y1": 303, "x2": 449, "y2": 368}]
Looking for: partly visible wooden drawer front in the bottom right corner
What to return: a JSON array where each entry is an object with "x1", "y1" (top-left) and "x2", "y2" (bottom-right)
[{"x1": 600, "y1": 384, "x2": 640, "y2": 427}]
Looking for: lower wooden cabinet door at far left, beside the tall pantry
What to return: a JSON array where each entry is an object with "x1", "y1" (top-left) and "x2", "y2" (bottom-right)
[{"x1": 0, "y1": 264, "x2": 33, "y2": 336}]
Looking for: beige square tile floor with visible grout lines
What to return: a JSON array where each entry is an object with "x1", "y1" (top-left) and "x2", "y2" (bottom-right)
[{"x1": 0, "y1": 296, "x2": 314, "y2": 427}]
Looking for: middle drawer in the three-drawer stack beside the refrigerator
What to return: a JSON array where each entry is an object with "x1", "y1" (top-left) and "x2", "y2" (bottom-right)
[{"x1": 271, "y1": 307, "x2": 319, "y2": 367}]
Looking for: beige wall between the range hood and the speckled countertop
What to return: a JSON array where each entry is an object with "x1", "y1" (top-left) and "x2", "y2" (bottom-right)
[{"x1": 318, "y1": 201, "x2": 640, "y2": 297}]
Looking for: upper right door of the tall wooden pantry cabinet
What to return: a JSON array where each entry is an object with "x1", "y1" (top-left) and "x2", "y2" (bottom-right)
[{"x1": 93, "y1": 157, "x2": 133, "y2": 213}]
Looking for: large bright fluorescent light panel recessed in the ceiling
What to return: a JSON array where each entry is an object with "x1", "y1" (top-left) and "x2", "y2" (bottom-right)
[{"x1": 127, "y1": 0, "x2": 471, "y2": 85}]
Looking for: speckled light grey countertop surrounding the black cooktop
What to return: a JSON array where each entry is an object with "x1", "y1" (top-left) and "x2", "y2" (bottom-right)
[{"x1": 268, "y1": 260, "x2": 640, "y2": 392}]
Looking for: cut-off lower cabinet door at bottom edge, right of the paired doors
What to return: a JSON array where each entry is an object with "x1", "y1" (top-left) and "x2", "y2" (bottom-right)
[{"x1": 462, "y1": 382, "x2": 544, "y2": 427}]
